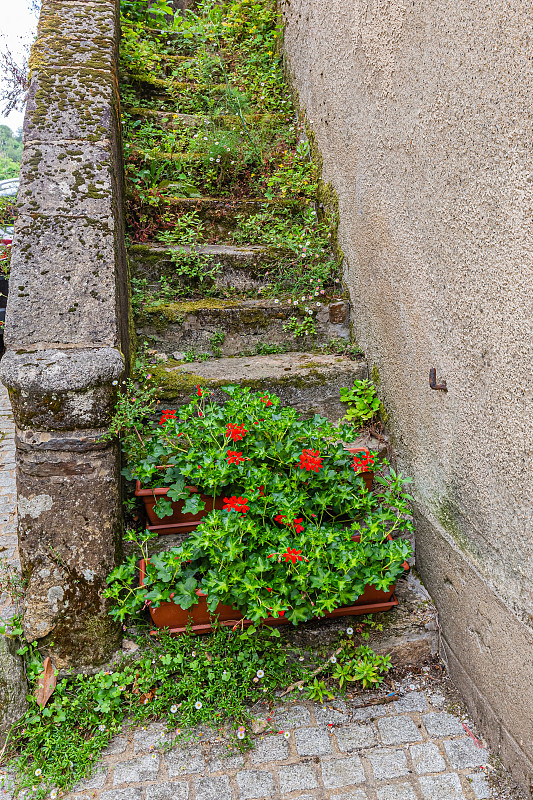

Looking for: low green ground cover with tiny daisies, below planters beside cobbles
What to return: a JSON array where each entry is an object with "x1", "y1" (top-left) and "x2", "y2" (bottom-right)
[{"x1": 5, "y1": 628, "x2": 304, "y2": 798}]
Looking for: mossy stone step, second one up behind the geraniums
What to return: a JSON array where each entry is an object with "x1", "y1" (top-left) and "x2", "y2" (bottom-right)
[{"x1": 135, "y1": 298, "x2": 350, "y2": 358}]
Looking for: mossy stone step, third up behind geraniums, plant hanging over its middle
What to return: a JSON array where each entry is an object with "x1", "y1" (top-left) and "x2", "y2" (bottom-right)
[{"x1": 128, "y1": 242, "x2": 295, "y2": 291}]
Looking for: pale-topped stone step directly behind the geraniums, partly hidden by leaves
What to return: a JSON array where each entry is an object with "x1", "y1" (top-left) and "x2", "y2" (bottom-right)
[{"x1": 151, "y1": 353, "x2": 368, "y2": 423}]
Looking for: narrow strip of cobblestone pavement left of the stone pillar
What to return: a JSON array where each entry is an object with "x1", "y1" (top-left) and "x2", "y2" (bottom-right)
[{"x1": 0, "y1": 383, "x2": 19, "y2": 619}]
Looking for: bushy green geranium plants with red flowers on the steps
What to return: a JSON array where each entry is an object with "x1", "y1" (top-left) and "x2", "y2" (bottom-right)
[{"x1": 108, "y1": 387, "x2": 411, "y2": 624}]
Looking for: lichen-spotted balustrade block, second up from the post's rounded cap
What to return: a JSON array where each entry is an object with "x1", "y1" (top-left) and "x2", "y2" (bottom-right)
[{"x1": 17, "y1": 142, "x2": 114, "y2": 218}]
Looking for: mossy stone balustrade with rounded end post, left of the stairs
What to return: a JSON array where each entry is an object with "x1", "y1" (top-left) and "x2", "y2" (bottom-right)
[{"x1": 0, "y1": 0, "x2": 129, "y2": 669}]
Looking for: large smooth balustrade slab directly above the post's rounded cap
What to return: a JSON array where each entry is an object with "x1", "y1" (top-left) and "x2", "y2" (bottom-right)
[{"x1": 5, "y1": 214, "x2": 120, "y2": 350}]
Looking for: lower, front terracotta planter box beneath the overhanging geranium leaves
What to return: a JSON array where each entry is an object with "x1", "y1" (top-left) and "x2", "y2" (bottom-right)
[{"x1": 139, "y1": 559, "x2": 408, "y2": 634}]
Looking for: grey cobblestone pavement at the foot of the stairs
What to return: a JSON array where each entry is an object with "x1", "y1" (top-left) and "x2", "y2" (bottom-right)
[{"x1": 60, "y1": 685, "x2": 519, "y2": 800}]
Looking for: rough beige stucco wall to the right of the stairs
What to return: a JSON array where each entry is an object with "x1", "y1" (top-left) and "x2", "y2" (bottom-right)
[{"x1": 281, "y1": 0, "x2": 533, "y2": 785}]
